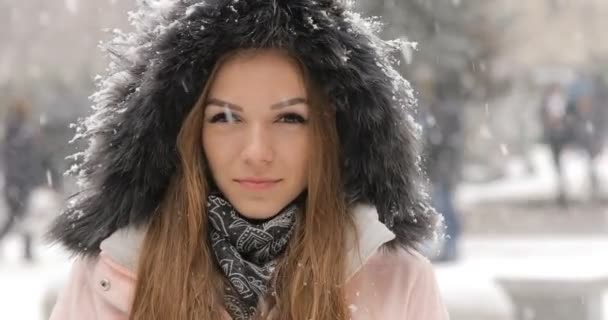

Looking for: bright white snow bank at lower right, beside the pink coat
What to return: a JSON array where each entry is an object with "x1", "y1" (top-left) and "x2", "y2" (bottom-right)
[{"x1": 436, "y1": 235, "x2": 608, "y2": 320}]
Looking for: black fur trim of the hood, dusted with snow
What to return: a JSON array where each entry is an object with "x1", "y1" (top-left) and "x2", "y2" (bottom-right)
[{"x1": 50, "y1": 0, "x2": 436, "y2": 254}]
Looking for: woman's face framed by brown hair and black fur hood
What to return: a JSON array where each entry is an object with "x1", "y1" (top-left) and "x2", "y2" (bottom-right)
[{"x1": 202, "y1": 50, "x2": 310, "y2": 219}]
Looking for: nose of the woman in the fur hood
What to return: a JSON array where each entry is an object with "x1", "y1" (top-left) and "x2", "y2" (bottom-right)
[{"x1": 243, "y1": 125, "x2": 274, "y2": 167}]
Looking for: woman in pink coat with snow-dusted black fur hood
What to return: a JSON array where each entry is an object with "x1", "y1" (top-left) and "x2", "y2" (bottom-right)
[{"x1": 51, "y1": 0, "x2": 447, "y2": 320}]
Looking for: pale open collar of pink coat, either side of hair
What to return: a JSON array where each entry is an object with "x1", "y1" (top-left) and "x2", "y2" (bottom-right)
[{"x1": 101, "y1": 204, "x2": 395, "y2": 281}]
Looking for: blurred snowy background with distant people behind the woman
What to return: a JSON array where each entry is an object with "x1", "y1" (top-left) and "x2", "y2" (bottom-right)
[{"x1": 0, "y1": 0, "x2": 608, "y2": 320}]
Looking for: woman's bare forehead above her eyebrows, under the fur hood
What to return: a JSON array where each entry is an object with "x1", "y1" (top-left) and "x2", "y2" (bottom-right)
[{"x1": 209, "y1": 50, "x2": 306, "y2": 104}]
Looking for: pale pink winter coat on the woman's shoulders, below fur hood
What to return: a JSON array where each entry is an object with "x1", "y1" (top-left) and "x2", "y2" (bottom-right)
[{"x1": 51, "y1": 206, "x2": 448, "y2": 320}]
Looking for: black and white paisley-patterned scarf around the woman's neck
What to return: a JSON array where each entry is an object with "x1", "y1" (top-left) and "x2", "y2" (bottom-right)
[{"x1": 207, "y1": 194, "x2": 299, "y2": 320}]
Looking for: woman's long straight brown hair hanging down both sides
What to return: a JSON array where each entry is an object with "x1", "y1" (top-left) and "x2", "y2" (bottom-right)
[{"x1": 130, "y1": 50, "x2": 355, "y2": 320}]
